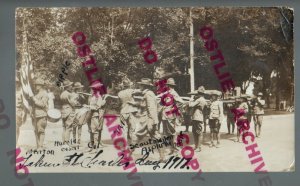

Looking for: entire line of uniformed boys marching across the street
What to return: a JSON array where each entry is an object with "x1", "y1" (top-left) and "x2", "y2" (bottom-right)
[{"x1": 17, "y1": 78, "x2": 265, "y2": 161}]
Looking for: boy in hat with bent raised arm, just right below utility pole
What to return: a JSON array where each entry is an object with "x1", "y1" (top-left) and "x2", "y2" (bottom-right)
[{"x1": 189, "y1": 86, "x2": 206, "y2": 151}]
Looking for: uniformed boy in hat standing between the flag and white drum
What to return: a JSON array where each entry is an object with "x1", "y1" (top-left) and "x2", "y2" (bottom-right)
[{"x1": 32, "y1": 79, "x2": 48, "y2": 148}]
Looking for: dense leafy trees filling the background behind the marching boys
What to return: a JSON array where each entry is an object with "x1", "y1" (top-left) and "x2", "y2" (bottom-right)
[{"x1": 16, "y1": 7, "x2": 294, "y2": 108}]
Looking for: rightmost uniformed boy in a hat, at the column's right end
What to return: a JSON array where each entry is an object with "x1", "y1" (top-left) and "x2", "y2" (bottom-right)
[{"x1": 253, "y1": 92, "x2": 265, "y2": 137}]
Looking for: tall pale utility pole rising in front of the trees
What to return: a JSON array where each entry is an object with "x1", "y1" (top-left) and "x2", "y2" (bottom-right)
[{"x1": 189, "y1": 8, "x2": 195, "y2": 91}]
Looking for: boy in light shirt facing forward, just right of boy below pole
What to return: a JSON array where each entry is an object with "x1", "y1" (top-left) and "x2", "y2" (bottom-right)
[{"x1": 209, "y1": 91, "x2": 223, "y2": 147}]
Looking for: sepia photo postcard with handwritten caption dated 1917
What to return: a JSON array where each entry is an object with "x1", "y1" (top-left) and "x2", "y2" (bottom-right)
[{"x1": 15, "y1": 7, "x2": 295, "y2": 175}]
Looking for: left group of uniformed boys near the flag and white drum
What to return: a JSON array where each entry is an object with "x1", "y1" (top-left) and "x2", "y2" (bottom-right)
[{"x1": 16, "y1": 79, "x2": 106, "y2": 151}]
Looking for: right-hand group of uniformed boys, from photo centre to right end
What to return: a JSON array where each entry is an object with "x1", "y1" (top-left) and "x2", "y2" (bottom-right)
[{"x1": 118, "y1": 78, "x2": 265, "y2": 159}]
